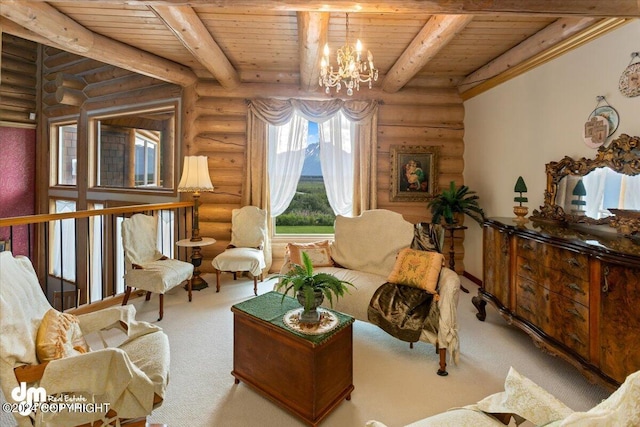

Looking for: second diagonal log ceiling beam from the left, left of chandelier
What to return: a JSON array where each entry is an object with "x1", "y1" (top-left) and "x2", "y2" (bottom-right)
[{"x1": 151, "y1": 6, "x2": 240, "y2": 89}]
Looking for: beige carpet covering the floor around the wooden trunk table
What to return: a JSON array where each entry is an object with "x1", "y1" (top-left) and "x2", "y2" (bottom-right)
[{"x1": 2, "y1": 275, "x2": 609, "y2": 427}]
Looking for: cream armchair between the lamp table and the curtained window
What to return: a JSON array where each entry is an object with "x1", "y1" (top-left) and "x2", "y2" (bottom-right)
[{"x1": 211, "y1": 206, "x2": 267, "y2": 295}]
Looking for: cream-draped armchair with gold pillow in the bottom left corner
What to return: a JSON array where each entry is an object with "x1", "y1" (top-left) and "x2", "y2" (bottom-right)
[{"x1": 0, "y1": 251, "x2": 169, "y2": 427}]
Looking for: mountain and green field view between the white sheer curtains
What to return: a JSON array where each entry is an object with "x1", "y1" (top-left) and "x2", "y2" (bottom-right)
[{"x1": 276, "y1": 122, "x2": 336, "y2": 234}]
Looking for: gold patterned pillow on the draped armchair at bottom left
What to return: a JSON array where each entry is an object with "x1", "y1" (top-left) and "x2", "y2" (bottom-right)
[{"x1": 36, "y1": 308, "x2": 89, "y2": 363}]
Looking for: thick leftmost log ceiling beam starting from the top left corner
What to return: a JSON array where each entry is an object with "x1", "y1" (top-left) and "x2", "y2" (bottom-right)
[{"x1": 0, "y1": 0, "x2": 198, "y2": 86}]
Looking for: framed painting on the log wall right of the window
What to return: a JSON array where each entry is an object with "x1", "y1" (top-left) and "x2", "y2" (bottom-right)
[{"x1": 390, "y1": 145, "x2": 439, "y2": 202}]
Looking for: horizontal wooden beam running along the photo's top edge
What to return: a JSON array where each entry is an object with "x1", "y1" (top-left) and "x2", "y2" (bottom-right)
[{"x1": 33, "y1": 0, "x2": 640, "y2": 18}]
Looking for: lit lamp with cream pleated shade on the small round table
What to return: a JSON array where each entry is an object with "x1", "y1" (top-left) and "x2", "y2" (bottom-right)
[{"x1": 178, "y1": 156, "x2": 213, "y2": 242}]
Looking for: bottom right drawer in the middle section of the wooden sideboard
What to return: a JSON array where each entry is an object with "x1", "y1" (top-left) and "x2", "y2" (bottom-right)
[{"x1": 549, "y1": 292, "x2": 589, "y2": 359}]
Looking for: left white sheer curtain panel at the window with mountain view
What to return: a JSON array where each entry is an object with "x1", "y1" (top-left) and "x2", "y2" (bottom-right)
[{"x1": 268, "y1": 114, "x2": 309, "y2": 217}]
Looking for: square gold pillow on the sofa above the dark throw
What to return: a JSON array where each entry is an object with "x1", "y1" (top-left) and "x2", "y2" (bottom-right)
[{"x1": 387, "y1": 248, "x2": 444, "y2": 294}]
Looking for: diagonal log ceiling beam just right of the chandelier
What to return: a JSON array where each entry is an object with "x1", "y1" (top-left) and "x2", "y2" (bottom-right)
[{"x1": 382, "y1": 15, "x2": 473, "y2": 93}]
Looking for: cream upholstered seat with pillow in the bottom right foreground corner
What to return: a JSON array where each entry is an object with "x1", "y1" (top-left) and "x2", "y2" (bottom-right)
[{"x1": 366, "y1": 368, "x2": 640, "y2": 427}]
